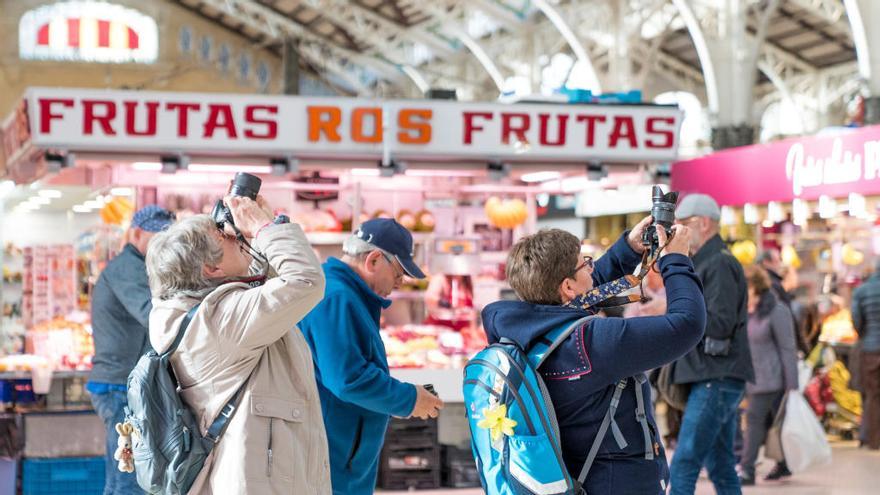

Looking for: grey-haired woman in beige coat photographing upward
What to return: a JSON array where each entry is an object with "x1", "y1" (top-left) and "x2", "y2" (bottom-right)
[{"x1": 147, "y1": 197, "x2": 331, "y2": 495}]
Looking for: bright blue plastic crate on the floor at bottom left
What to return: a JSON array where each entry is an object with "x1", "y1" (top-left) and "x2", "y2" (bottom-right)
[{"x1": 21, "y1": 457, "x2": 105, "y2": 495}]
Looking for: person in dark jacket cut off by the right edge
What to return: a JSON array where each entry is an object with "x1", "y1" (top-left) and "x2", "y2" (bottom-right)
[{"x1": 852, "y1": 261, "x2": 880, "y2": 450}]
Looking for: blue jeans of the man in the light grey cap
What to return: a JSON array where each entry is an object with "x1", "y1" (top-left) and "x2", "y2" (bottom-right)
[{"x1": 670, "y1": 378, "x2": 746, "y2": 495}]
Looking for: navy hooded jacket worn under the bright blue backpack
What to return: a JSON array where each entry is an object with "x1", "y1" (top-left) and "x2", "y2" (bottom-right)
[{"x1": 483, "y1": 236, "x2": 706, "y2": 495}]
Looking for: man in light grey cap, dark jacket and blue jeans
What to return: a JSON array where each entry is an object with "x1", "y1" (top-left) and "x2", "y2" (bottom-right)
[{"x1": 671, "y1": 194, "x2": 755, "y2": 495}]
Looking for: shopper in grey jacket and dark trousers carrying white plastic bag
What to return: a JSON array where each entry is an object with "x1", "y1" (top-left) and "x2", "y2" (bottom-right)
[{"x1": 740, "y1": 266, "x2": 798, "y2": 486}]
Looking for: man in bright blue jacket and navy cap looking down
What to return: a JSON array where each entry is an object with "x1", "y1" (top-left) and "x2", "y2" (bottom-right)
[{"x1": 299, "y1": 219, "x2": 443, "y2": 495}]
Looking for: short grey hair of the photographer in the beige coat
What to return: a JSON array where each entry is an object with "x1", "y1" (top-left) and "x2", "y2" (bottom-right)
[{"x1": 147, "y1": 215, "x2": 223, "y2": 300}]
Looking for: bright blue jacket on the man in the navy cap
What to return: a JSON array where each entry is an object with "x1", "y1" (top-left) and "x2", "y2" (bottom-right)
[{"x1": 299, "y1": 258, "x2": 416, "y2": 495}]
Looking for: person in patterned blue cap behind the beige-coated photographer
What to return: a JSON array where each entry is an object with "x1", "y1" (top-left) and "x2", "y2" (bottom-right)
[{"x1": 86, "y1": 205, "x2": 174, "y2": 495}]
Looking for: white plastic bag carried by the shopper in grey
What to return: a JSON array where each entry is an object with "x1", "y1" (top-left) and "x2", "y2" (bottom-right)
[{"x1": 782, "y1": 390, "x2": 831, "y2": 473}]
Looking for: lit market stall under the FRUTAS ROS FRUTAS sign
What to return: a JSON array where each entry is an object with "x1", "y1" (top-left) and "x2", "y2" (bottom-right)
[{"x1": 0, "y1": 88, "x2": 682, "y2": 492}]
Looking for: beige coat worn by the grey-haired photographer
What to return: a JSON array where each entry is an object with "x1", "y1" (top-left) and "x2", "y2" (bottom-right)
[{"x1": 150, "y1": 224, "x2": 331, "y2": 495}]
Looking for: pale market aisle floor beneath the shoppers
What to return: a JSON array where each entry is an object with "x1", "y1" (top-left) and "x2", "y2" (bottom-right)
[{"x1": 379, "y1": 442, "x2": 880, "y2": 495}]
